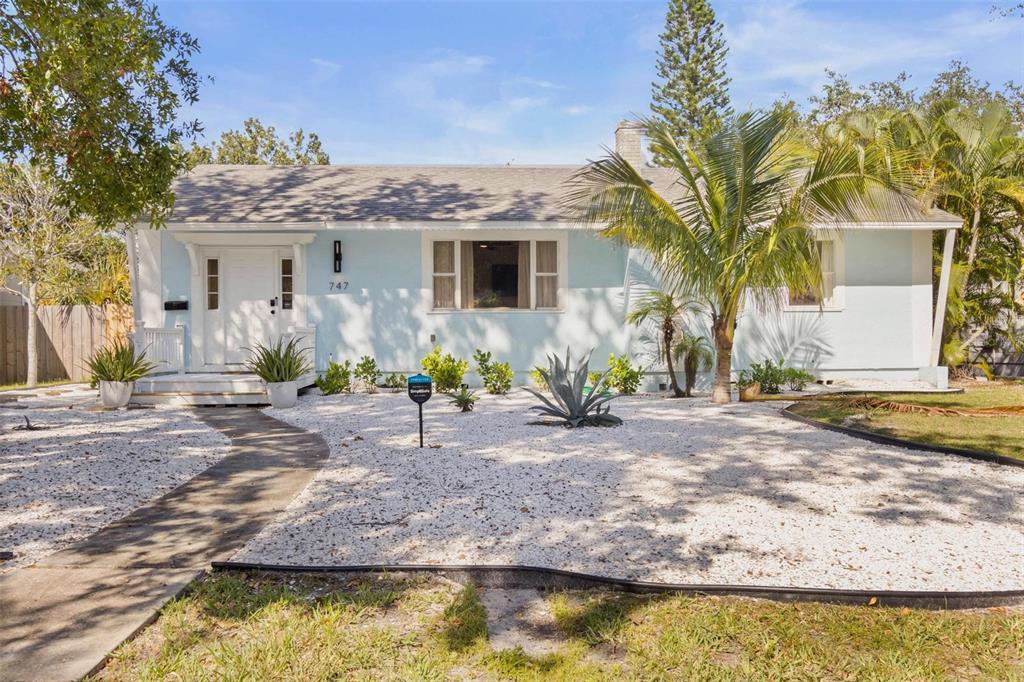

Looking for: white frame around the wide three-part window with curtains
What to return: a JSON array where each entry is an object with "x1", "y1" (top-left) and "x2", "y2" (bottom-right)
[{"x1": 420, "y1": 227, "x2": 568, "y2": 314}]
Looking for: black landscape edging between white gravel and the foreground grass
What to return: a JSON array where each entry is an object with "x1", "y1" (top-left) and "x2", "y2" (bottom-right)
[{"x1": 211, "y1": 561, "x2": 1024, "y2": 610}]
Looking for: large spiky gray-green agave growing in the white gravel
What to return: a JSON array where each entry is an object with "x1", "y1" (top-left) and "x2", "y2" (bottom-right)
[{"x1": 523, "y1": 348, "x2": 623, "y2": 428}]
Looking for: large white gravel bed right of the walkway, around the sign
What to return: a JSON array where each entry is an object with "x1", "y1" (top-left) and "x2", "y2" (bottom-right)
[{"x1": 234, "y1": 391, "x2": 1024, "y2": 590}]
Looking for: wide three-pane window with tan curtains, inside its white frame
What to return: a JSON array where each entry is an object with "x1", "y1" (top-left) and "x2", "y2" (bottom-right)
[{"x1": 431, "y1": 240, "x2": 562, "y2": 310}]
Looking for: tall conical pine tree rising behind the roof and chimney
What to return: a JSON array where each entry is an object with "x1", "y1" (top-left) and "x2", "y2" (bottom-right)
[{"x1": 650, "y1": 0, "x2": 732, "y2": 155}]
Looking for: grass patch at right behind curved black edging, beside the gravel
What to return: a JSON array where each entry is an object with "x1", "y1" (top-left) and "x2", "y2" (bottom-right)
[{"x1": 792, "y1": 381, "x2": 1024, "y2": 459}]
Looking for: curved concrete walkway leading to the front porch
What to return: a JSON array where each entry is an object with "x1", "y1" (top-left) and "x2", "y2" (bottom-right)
[{"x1": 0, "y1": 409, "x2": 328, "y2": 681}]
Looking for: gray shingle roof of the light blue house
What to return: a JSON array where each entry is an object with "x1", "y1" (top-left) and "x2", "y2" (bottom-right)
[{"x1": 170, "y1": 165, "x2": 958, "y2": 224}]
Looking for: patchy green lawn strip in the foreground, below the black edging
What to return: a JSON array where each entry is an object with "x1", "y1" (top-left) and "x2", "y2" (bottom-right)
[{"x1": 96, "y1": 573, "x2": 1024, "y2": 682}]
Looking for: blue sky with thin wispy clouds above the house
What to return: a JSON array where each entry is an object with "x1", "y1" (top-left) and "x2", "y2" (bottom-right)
[{"x1": 159, "y1": 0, "x2": 1024, "y2": 164}]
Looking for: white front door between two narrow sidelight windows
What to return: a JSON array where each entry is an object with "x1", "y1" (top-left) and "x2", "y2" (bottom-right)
[{"x1": 218, "y1": 248, "x2": 280, "y2": 365}]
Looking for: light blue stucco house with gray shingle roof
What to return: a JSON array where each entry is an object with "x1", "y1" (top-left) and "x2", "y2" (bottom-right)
[{"x1": 129, "y1": 124, "x2": 959, "y2": 402}]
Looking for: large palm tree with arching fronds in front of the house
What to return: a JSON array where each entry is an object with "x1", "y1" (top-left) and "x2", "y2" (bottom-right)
[{"x1": 565, "y1": 111, "x2": 906, "y2": 402}]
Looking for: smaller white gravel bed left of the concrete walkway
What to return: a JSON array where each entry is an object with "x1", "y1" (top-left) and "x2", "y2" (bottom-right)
[{"x1": 0, "y1": 399, "x2": 228, "y2": 571}]
